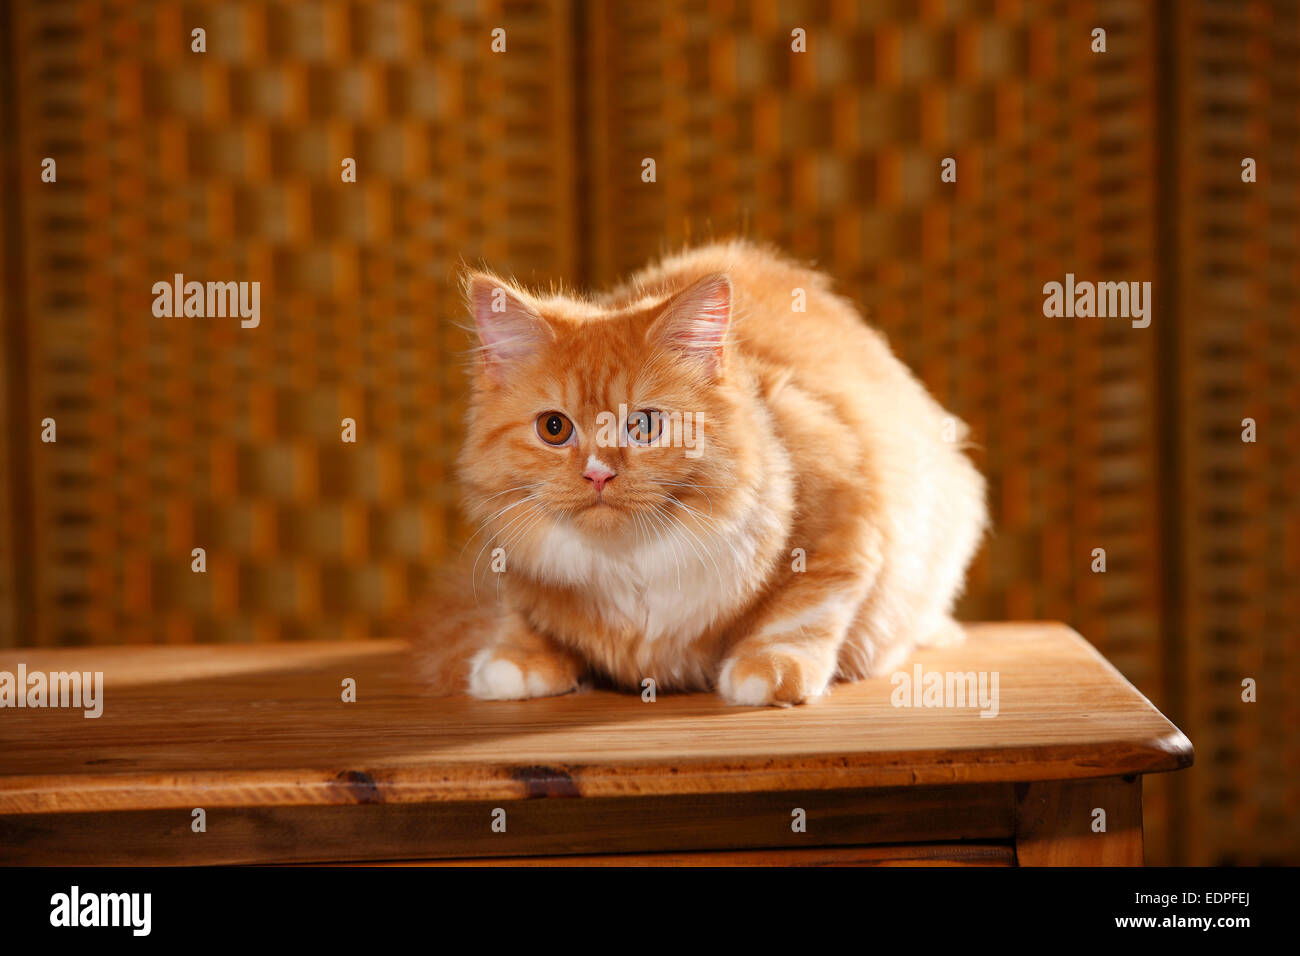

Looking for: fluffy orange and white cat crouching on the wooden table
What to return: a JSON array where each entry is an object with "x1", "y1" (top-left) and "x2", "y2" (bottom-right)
[{"x1": 417, "y1": 239, "x2": 988, "y2": 706}]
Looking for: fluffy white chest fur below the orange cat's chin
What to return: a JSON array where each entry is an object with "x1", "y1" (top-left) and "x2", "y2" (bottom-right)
[{"x1": 536, "y1": 515, "x2": 757, "y2": 645}]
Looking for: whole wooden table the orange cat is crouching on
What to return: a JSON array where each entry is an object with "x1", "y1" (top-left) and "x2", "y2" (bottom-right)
[{"x1": 0, "y1": 623, "x2": 1192, "y2": 865}]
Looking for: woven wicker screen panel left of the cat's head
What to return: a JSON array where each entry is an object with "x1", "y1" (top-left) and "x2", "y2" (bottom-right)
[{"x1": 9, "y1": 1, "x2": 575, "y2": 644}]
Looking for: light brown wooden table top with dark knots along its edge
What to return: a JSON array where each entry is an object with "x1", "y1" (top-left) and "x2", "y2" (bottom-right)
[{"x1": 0, "y1": 623, "x2": 1192, "y2": 814}]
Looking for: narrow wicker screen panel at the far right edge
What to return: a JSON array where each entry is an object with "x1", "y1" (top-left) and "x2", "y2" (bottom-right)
[{"x1": 1170, "y1": 3, "x2": 1300, "y2": 864}]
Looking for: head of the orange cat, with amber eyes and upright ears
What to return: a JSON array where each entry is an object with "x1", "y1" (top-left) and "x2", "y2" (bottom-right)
[{"x1": 460, "y1": 273, "x2": 763, "y2": 551}]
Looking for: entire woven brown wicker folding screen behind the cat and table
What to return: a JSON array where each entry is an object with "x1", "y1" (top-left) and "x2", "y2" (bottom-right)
[{"x1": 0, "y1": 0, "x2": 1300, "y2": 864}]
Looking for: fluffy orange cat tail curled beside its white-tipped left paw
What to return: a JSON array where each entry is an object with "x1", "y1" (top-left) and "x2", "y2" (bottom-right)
[{"x1": 406, "y1": 567, "x2": 501, "y2": 697}]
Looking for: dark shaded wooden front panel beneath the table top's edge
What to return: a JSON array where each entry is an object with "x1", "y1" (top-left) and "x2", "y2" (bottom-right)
[{"x1": 0, "y1": 783, "x2": 1017, "y2": 866}]
